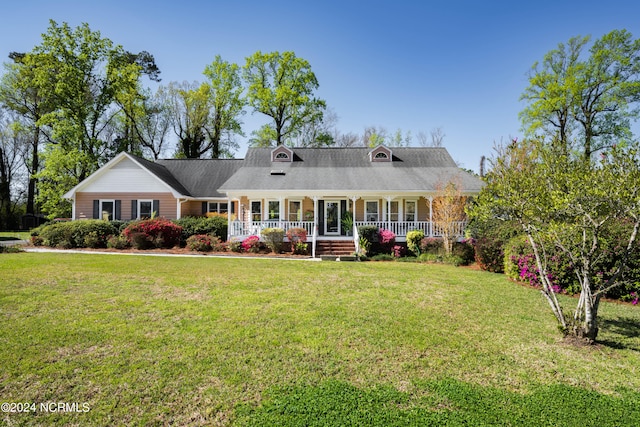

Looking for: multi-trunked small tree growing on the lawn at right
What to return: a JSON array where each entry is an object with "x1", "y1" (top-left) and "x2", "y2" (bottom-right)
[{"x1": 470, "y1": 141, "x2": 640, "y2": 342}]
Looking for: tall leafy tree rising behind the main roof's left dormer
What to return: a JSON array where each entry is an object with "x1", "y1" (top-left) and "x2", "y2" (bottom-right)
[{"x1": 244, "y1": 51, "x2": 326, "y2": 145}]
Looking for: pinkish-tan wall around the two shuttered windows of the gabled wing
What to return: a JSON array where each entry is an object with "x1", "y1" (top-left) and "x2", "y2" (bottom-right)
[{"x1": 74, "y1": 192, "x2": 177, "y2": 221}]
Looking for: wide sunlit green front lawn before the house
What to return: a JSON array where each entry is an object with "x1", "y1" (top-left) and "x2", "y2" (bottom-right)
[{"x1": 0, "y1": 253, "x2": 640, "y2": 426}]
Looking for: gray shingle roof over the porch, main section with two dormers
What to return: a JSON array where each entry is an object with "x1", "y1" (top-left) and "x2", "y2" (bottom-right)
[{"x1": 220, "y1": 147, "x2": 482, "y2": 192}]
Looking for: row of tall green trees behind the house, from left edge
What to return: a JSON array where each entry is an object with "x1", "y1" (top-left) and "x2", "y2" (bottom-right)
[{"x1": 0, "y1": 21, "x2": 444, "y2": 229}]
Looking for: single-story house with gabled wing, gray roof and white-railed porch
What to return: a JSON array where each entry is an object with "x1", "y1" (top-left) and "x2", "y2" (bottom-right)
[{"x1": 65, "y1": 146, "x2": 482, "y2": 254}]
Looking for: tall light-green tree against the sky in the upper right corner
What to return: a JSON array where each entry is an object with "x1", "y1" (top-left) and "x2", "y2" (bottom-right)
[{"x1": 520, "y1": 30, "x2": 640, "y2": 159}]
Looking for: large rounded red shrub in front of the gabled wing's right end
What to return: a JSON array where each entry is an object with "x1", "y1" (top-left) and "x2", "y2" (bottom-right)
[{"x1": 122, "y1": 218, "x2": 182, "y2": 249}]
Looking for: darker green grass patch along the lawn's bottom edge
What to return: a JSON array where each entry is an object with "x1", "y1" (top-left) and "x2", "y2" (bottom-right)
[{"x1": 234, "y1": 380, "x2": 640, "y2": 426}]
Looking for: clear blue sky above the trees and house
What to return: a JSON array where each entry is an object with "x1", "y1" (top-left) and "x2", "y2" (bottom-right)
[{"x1": 0, "y1": 0, "x2": 640, "y2": 171}]
